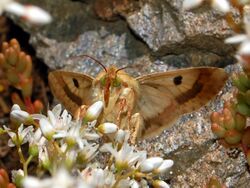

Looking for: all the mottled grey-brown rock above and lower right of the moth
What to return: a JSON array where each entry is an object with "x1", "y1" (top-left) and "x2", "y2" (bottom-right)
[{"x1": 11, "y1": 0, "x2": 250, "y2": 188}]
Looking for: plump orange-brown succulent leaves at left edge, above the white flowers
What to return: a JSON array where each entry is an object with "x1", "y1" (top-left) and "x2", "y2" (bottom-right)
[{"x1": 0, "y1": 39, "x2": 43, "y2": 113}]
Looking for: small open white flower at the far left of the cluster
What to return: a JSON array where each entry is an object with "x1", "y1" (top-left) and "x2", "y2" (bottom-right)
[{"x1": 4, "y1": 124, "x2": 34, "y2": 147}]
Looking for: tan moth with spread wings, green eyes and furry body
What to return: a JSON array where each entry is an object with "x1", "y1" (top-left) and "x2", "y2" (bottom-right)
[{"x1": 49, "y1": 56, "x2": 228, "y2": 139}]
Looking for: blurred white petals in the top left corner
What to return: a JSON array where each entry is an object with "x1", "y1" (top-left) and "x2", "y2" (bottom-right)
[{"x1": 4, "y1": 0, "x2": 52, "y2": 24}]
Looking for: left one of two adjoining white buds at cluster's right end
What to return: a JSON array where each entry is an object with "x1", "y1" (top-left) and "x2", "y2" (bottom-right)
[{"x1": 140, "y1": 157, "x2": 163, "y2": 173}]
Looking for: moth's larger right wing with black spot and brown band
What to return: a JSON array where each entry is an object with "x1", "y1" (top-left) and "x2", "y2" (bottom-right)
[{"x1": 136, "y1": 67, "x2": 227, "y2": 138}]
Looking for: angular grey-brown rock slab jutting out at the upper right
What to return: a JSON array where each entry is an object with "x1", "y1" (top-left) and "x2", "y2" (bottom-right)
[{"x1": 126, "y1": 0, "x2": 232, "y2": 55}]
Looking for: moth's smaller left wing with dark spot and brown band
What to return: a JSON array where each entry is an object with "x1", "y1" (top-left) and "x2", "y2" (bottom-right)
[{"x1": 49, "y1": 71, "x2": 94, "y2": 114}]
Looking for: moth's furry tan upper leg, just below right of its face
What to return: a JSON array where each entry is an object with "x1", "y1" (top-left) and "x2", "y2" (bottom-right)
[{"x1": 117, "y1": 88, "x2": 135, "y2": 128}]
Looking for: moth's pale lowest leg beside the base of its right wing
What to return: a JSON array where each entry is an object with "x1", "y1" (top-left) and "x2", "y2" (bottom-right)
[{"x1": 129, "y1": 113, "x2": 144, "y2": 144}]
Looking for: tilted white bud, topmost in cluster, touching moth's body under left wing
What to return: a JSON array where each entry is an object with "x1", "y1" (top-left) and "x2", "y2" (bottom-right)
[{"x1": 84, "y1": 101, "x2": 104, "y2": 122}]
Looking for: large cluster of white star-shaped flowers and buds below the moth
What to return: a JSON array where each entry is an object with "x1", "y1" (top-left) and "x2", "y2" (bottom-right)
[{"x1": 0, "y1": 101, "x2": 173, "y2": 188}]
